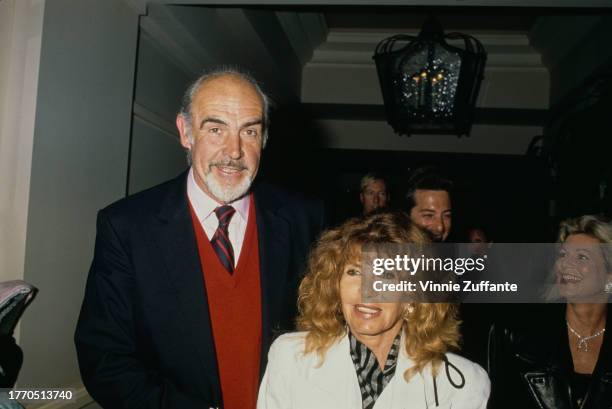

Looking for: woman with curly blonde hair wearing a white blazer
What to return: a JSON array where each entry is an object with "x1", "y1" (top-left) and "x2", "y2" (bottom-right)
[{"x1": 257, "y1": 213, "x2": 490, "y2": 409}]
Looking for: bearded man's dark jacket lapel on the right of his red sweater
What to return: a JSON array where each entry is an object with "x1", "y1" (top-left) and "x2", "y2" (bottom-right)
[{"x1": 254, "y1": 189, "x2": 291, "y2": 376}]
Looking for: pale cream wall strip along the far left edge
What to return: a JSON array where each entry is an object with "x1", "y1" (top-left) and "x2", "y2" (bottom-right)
[{"x1": 0, "y1": 0, "x2": 45, "y2": 286}]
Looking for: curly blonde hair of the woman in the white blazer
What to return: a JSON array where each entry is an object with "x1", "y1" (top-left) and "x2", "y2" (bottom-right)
[{"x1": 297, "y1": 212, "x2": 460, "y2": 381}]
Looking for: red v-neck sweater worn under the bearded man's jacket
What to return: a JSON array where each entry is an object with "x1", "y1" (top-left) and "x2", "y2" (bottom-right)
[{"x1": 191, "y1": 195, "x2": 261, "y2": 409}]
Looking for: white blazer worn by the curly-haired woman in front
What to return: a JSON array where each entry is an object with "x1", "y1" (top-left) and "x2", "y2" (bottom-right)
[{"x1": 257, "y1": 332, "x2": 490, "y2": 409}]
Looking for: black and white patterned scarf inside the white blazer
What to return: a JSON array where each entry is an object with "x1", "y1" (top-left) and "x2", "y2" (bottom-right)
[{"x1": 349, "y1": 331, "x2": 401, "y2": 409}]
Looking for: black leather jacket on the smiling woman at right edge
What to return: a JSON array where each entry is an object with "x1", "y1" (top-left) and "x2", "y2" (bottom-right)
[{"x1": 489, "y1": 304, "x2": 612, "y2": 409}]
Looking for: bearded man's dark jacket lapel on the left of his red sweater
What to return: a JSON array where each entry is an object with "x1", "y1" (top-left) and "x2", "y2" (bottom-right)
[{"x1": 151, "y1": 173, "x2": 221, "y2": 401}]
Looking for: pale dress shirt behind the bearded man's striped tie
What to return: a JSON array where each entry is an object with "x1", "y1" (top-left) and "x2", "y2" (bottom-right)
[{"x1": 187, "y1": 168, "x2": 251, "y2": 265}]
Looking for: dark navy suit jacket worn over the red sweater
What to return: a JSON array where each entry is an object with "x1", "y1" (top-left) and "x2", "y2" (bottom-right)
[{"x1": 75, "y1": 173, "x2": 324, "y2": 409}]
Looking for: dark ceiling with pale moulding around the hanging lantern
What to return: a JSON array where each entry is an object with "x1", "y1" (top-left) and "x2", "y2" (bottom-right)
[{"x1": 141, "y1": 5, "x2": 612, "y2": 155}]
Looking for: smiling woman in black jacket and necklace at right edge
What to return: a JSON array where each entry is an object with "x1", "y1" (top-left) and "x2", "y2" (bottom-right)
[{"x1": 489, "y1": 216, "x2": 612, "y2": 409}]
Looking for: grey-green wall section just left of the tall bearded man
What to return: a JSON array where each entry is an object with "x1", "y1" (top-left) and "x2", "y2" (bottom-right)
[{"x1": 19, "y1": 0, "x2": 138, "y2": 392}]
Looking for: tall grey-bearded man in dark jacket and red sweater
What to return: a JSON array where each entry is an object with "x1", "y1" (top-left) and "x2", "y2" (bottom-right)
[{"x1": 75, "y1": 70, "x2": 323, "y2": 409}]
